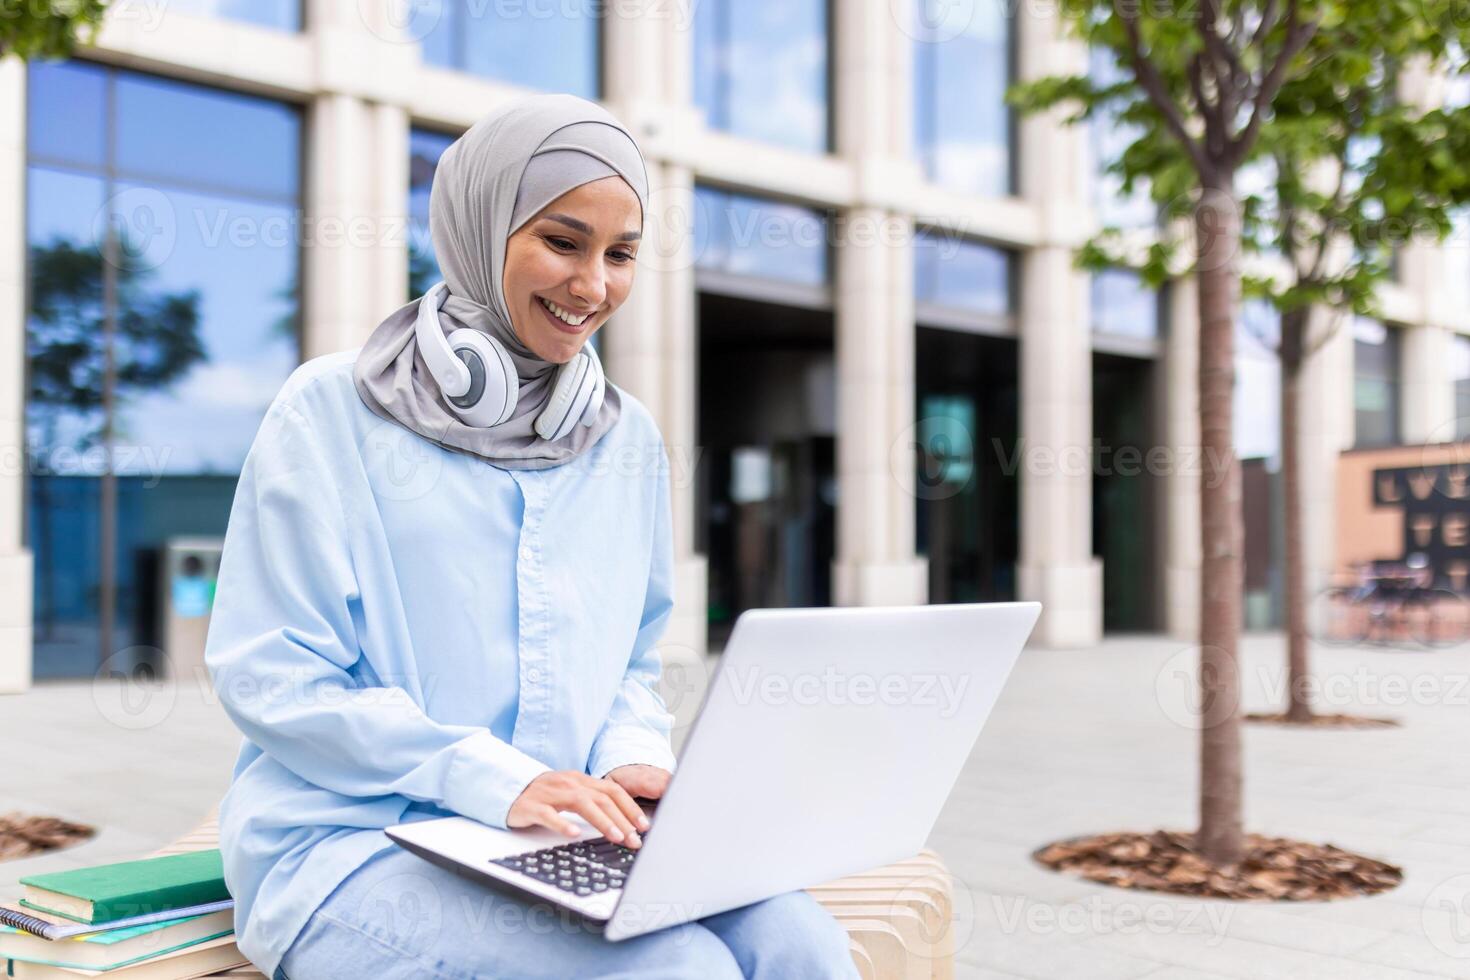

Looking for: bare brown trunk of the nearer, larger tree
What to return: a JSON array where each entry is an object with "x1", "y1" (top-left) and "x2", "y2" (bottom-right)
[{"x1": 1195, "y1": 178, "x2": 1245, "y2": 865}]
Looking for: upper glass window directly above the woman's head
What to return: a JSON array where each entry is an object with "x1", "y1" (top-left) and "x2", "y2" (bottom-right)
[{"x1": 420, "y1": 0, "x2": 604, "y2": 98}]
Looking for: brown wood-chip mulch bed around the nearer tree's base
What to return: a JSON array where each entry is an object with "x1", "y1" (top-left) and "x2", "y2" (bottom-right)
[{"x1": 1032, "y1": 830, "x2": 1404, "y2": 902}]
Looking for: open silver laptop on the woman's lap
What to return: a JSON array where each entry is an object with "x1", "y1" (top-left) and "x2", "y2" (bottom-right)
[{"x1": 387, "y1": 602, "x2": 1041, "y2": 940}]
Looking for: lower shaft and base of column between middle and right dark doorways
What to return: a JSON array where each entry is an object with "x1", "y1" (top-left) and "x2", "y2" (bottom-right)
[{"x1": 1017, "y1": 245, "x2": 1103, "y2": 646}]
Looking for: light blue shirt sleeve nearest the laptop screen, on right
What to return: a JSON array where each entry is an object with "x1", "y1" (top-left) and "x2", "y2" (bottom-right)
[{"x1": 587, "y1": 443, "x2": 673, "y2": 777}]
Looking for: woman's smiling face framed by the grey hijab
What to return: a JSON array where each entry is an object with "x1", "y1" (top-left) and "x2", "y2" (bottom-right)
[{"x1": 501, "y1": 176, "x2": 642, "y2": 364}]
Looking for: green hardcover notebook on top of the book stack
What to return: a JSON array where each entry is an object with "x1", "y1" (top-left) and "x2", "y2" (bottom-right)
[{"x1": 21, "y1": 849, "x2": 229, "y2": 923}]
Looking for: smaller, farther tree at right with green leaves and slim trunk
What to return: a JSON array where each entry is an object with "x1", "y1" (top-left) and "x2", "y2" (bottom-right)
[{"x1": 1244, "y1": 26, "x2": 1470, "y2": 723}]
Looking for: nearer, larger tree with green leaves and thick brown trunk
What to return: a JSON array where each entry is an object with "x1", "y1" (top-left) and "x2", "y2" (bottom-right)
[{"x1": 1014, "y1": 0, "x2": 1454, "y2": 865}]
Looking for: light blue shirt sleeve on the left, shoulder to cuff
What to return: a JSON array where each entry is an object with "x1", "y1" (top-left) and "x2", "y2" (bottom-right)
[{"x1": 204, "y1": 401, "x2": 548, "y2": 827}]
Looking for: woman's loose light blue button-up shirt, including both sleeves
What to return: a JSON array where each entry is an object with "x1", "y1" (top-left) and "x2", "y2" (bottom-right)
[{"x1": 204, "y1": 351, "x2": 673, "y2": 977}]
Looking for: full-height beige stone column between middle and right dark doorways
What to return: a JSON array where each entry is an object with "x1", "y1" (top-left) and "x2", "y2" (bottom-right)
[{"x1": 1016, "y1": 10, "x2": 1103, "y2": 646}]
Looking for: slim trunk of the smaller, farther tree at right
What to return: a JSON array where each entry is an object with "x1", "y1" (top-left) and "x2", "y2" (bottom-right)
[{"x1": 1280, "y1": 307, "x2": 1311, "y2": 724}]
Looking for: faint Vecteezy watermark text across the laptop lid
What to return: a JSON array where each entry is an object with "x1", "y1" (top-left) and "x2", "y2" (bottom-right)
[{"x1": 717, "y1": 664, "x2": 970, "y2": 718}]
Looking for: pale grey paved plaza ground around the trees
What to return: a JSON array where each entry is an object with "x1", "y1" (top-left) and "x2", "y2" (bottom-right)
[{"x1": 0, "y1": 635, "x2": 1470, "y2": 980}]
